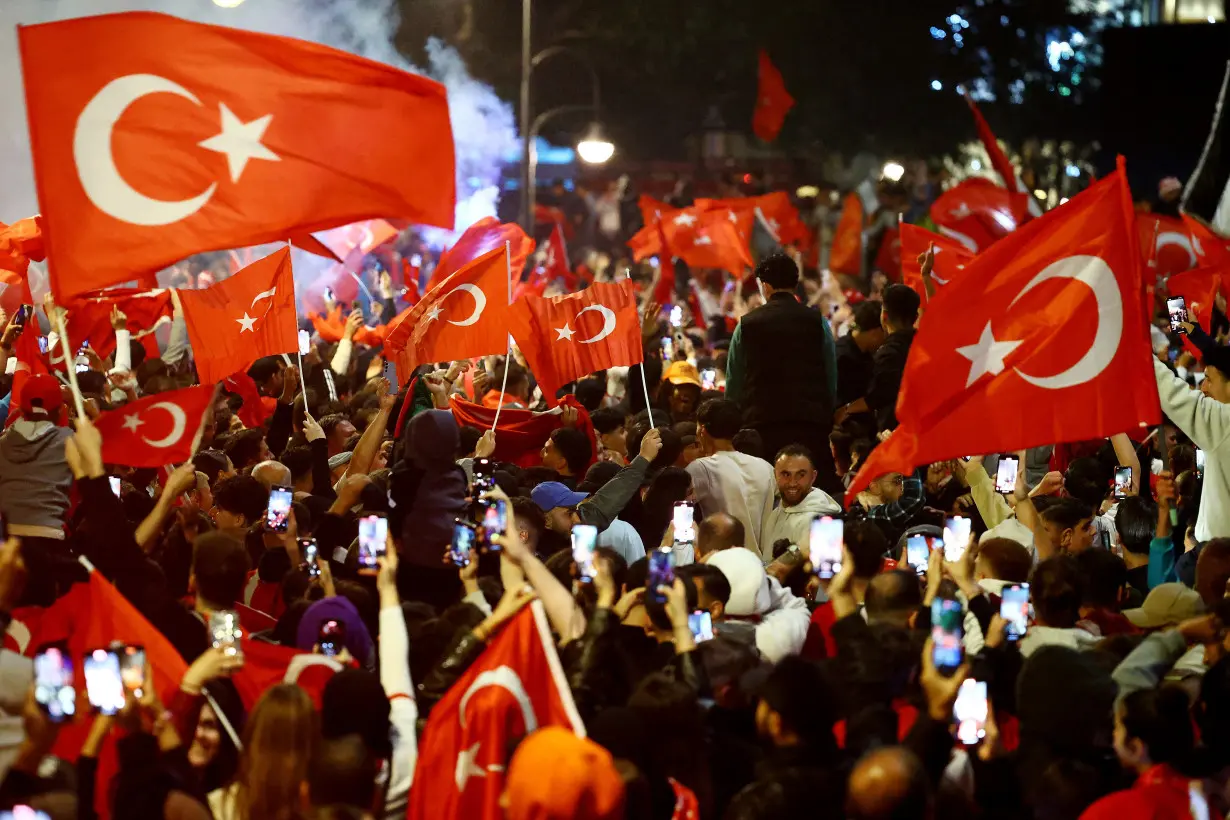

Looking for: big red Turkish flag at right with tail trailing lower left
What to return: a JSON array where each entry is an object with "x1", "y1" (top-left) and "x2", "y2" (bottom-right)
[{"x1": 846, "y1": 160, "x2": 1161, "y2": 500}]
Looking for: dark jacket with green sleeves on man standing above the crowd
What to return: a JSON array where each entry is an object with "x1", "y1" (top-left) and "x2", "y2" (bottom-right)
[{"x1": 727, "y1": 293, "x2": 836, "y2": 432}]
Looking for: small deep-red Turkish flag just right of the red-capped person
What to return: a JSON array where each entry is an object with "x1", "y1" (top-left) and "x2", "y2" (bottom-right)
[{"x1": 93, "y1": 385, "x2": 214, "y2": 467}]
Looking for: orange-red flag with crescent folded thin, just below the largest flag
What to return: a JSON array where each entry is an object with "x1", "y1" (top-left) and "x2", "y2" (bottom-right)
[{"x1": 180, "y1": 248, "x2": 299, "y2": 385}]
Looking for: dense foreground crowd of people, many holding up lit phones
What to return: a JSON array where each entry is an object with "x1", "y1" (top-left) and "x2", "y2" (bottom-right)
[{"x1": 0, "y1": 167, "x2": 1230, "y2": 820}]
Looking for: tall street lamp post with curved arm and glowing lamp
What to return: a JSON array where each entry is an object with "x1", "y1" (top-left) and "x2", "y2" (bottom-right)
[{"x1": 520, "y1": 0, "x2": 615, "y2": 236}]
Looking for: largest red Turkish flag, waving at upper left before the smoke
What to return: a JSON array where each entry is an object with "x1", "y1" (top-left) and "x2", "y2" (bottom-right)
[{"x1": 17, "y1": 12, "x2": 455, "y2": 301}]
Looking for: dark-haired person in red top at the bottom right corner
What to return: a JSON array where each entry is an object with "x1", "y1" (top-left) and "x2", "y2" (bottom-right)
[{"x1": 1081, "y1": 686, "x2": 1196, "y2": 820}]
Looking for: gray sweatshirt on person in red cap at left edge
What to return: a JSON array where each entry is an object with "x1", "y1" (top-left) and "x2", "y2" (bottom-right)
[{"x1": 0, "y1": 419, "x2": 73, "y2": 538}]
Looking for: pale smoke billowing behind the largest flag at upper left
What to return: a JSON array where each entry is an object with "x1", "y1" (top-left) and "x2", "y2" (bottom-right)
[{"x1": 0, "y1": 0, "x2": 519, "y2": 231}]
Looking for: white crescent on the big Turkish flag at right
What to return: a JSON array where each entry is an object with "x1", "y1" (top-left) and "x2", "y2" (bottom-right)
[{"x1": 1009, "y1": 256, "x2": 1123, "y2": 390}]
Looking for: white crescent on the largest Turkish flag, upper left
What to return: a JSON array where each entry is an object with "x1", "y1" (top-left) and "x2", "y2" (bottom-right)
[{"x1": 73, "y1": 74, "x2": 218, "y2": 226}]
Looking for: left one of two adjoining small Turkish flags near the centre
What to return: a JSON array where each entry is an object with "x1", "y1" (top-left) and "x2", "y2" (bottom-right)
[{"x1": 385, "y1": 247, "x2": 509, "y2": 381}]
